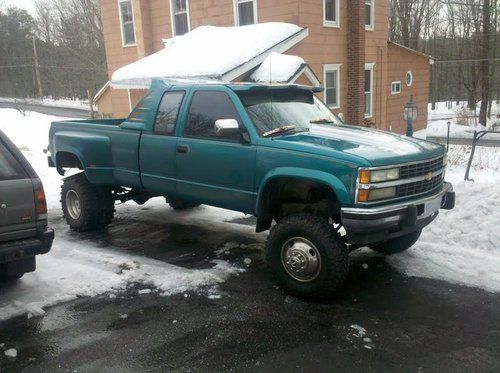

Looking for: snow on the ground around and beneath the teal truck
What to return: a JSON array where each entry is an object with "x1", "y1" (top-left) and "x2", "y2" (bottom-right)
[{"x1": 0, "y1": 109, "x2": 500, "y2": 320}]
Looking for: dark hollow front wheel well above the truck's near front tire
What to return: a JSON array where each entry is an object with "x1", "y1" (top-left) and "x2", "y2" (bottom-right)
[{"x1": 257, "y1": 177, "x2": 340, "y2": 232}]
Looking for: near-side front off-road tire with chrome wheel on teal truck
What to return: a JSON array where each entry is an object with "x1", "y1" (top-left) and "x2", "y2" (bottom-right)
[{"x1": 266, "y1": 214, "x2": 349, "y2": 299}]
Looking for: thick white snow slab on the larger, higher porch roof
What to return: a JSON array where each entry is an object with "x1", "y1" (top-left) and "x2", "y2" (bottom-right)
[{"x1": 111, "y1": 22, "x2": 308, "y2": 88}]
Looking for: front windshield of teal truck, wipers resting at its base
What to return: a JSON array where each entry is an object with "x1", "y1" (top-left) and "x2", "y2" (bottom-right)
[{"x1": 238, "y1": 90, "x2": 342, "y2": 137}]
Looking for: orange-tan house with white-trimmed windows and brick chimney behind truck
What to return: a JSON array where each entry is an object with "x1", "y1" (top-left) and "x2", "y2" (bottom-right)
[{"x1": 96, "y1": 0, "x2": 432, "y2": 133}]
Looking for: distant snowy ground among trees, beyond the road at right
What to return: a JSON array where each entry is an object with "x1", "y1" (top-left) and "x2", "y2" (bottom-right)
[{"x1": 424, "y1": 102, "x2": 500, "y2": 139}]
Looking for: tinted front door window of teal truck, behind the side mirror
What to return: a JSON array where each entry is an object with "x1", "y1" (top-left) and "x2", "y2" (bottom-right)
[{"x1": 184, "y1": 91, "x2": 242, "y2": 141}]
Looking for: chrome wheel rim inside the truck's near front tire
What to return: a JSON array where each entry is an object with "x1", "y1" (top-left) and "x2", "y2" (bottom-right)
[{"x1": 281, "y1": 237, "x2": 321, "y2": 282}]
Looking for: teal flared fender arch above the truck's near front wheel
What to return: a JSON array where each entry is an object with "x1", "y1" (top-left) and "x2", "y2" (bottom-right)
[{"x1": 255, "y1": 167, "x2": 351, "y2": 232}]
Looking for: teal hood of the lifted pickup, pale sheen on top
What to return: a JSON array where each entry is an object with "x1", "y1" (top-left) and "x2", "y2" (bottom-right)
[{"x1": 274, "y1": 125, "x2": 445, "y2": 166}]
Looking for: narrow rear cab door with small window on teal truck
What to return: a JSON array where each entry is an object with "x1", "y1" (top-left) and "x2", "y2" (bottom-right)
[{"x1": 139, "y1": 90, "x2": 186, "y2": 196}]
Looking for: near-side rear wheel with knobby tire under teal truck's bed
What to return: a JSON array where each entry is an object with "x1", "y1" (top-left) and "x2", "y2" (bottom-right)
[{"x1": 61, "y1": 173, "x2": 115, "y2": 232}]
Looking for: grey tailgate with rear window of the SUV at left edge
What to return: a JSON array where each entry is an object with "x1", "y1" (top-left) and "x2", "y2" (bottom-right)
[{"x1": 0, "y1": 142, "x2": 36, "y2": 242}]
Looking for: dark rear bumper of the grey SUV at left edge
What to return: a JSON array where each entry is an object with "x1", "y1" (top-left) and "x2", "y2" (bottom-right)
[{"x1": 0, "y1": 228, "x2": 54, "y2": 263}]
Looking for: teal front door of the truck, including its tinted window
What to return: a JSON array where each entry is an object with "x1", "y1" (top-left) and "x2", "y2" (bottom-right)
[{"x1": 175, "y1": 87, "x2": 256, "y2": 212}]
